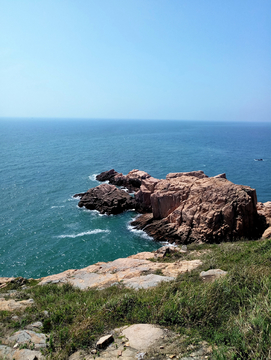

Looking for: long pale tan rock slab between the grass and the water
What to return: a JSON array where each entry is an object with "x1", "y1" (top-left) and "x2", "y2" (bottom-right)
[{"x1": 39, "y1": 253, "x2": 202, "y2": 290}]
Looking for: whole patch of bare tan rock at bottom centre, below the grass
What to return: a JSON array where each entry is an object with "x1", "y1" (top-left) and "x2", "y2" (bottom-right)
[{"x1": 69, "y1": 324, "x2": 215, "y2": 360}]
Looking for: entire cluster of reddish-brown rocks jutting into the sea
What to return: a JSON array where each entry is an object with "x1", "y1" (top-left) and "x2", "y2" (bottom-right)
[{"x1": 76, "y1": 169, "x2": 271, "y2": 244}]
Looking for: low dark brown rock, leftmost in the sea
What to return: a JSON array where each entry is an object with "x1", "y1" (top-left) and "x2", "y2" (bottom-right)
[{"x1": 74, "y1": 184, "x2": 135, "y2": 215}]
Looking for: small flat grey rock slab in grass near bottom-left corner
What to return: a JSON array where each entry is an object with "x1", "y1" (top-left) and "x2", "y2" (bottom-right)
[{"x1": 8, "y1": 330, "x2": 46, "y2": 349}]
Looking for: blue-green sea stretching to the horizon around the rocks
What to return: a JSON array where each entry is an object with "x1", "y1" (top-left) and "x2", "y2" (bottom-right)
[{"x1": 0, "y1": 119, "x2": 271, "y2": 278}]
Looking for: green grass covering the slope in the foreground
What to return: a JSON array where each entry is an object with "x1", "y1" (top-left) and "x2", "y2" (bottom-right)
[{"x1": 0, "y1": 240, "x2": 271, "y2": 360}]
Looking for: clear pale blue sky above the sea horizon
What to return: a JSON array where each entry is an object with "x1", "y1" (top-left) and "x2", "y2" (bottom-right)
[{"x1": 0, "y1": 0, "x2": 271, "y2": 121}]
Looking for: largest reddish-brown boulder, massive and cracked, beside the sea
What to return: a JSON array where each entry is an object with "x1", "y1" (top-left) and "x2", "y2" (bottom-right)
[{"x1": 132, "y1": 171, "x2": 266, "y2": 243}]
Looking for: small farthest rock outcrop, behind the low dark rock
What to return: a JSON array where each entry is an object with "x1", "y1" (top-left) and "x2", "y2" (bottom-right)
[{"x1": 96, "y1": 169, "x2": 150, "y2": 191}]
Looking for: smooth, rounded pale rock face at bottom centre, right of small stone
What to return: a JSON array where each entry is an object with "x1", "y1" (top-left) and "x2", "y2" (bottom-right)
[{"x1": 122, "y1": 324, "x2": 164, "y2": 351}]
